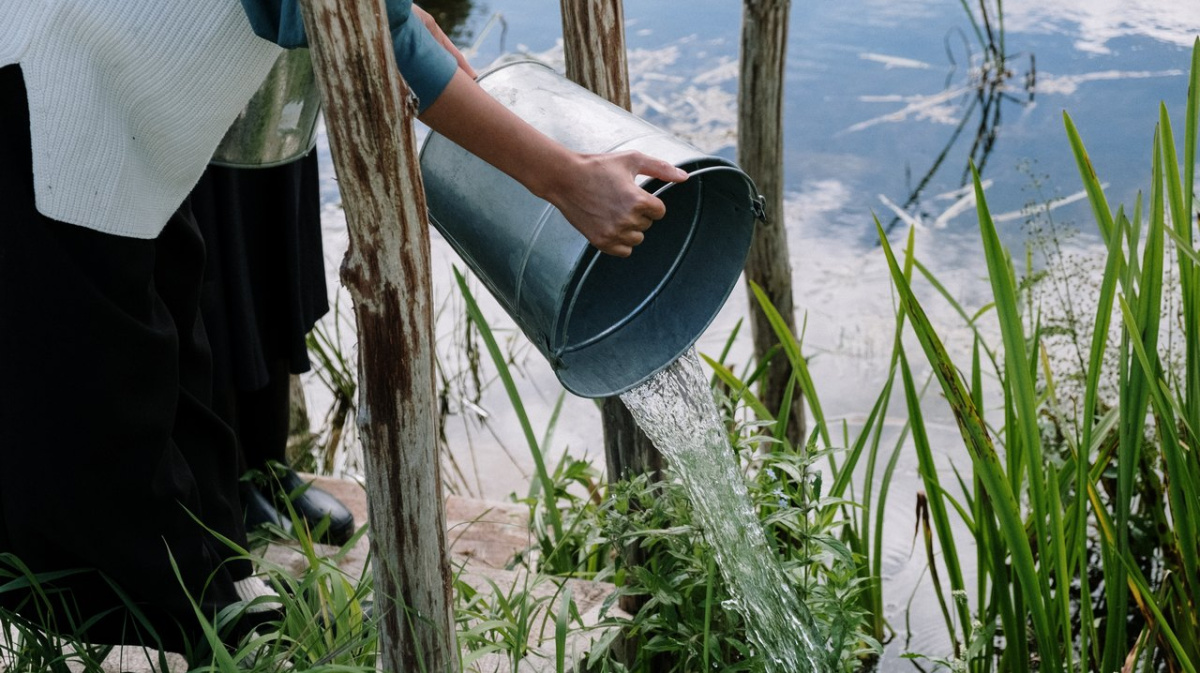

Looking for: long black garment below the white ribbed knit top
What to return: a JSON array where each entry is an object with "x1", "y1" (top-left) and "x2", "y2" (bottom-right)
[{"x1": 0, "y1": 66, "x2": 252, "y2": 651}]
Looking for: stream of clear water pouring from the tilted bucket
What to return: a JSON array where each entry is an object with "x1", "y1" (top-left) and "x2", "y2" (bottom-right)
[{"x1": 620, "y1": 350, "x2": 828, "y2": 673}]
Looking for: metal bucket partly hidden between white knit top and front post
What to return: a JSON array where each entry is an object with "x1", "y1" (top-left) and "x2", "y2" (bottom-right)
[{"x1": 211, "y1": 49, "x2": 320, "y2": 168}]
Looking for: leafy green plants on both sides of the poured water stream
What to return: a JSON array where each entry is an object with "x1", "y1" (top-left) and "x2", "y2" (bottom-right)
[{"x1": 457, "y1": 275, "x2": 878, "y2": 672}]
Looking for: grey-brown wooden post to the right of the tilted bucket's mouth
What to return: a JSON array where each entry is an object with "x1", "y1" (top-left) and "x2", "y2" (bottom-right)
[{"x1": 738, "y1": 0, "x2": 805, "y2": 443}]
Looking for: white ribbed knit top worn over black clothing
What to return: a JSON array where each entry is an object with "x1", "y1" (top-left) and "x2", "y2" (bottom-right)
[{"x1": 0, "y1": 0, "x2": 280, "y2": 239}]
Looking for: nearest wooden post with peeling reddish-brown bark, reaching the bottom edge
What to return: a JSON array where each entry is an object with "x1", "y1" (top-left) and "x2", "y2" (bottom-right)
[{"x1": 301, "y1": 0, "x2": 458, "y2": 673}]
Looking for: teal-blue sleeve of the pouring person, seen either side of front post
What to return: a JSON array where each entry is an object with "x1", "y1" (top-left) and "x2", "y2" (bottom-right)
[{"x1": 241, "y1": 0, "x2": 458, "y2": 112}]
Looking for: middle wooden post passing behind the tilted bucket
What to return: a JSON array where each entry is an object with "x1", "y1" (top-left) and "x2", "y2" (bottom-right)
[{"x1": 560, "y1": 0, "x2": 662, "y2": 501}]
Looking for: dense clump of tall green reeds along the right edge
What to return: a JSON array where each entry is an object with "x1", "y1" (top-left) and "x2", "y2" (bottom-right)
[{"x1": 880, "y1": 41, "x2": 1200, "y2": 671}]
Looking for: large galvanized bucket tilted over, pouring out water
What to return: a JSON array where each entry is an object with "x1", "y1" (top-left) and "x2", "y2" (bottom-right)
[{"x1": 421, "y1": 60, "x2": 761, "y2": 397}]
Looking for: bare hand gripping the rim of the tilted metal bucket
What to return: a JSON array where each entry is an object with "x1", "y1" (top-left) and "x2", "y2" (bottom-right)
[{"x1": 538, "y1": 151, "x2": 688, "y2": 257}]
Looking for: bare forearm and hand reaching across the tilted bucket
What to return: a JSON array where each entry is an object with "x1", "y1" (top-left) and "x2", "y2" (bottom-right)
[{"x1": 420, "y1": 70, "x2": 688, "y2": 257}]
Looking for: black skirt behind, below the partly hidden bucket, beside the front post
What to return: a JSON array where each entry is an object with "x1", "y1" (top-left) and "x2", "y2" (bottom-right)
[{"x1": 191, "y1": 150, "x2": 329, "y2": 391}]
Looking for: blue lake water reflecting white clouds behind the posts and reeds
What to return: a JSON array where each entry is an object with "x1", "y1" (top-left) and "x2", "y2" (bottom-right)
[{"x1": 308, "y1": 0, "x2": 1200, "y2": 662}]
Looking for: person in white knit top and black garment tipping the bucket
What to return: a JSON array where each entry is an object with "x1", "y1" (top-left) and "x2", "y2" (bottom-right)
[{"x1": 0, "y1": 0, "x2": 686, "y2": 650}]
